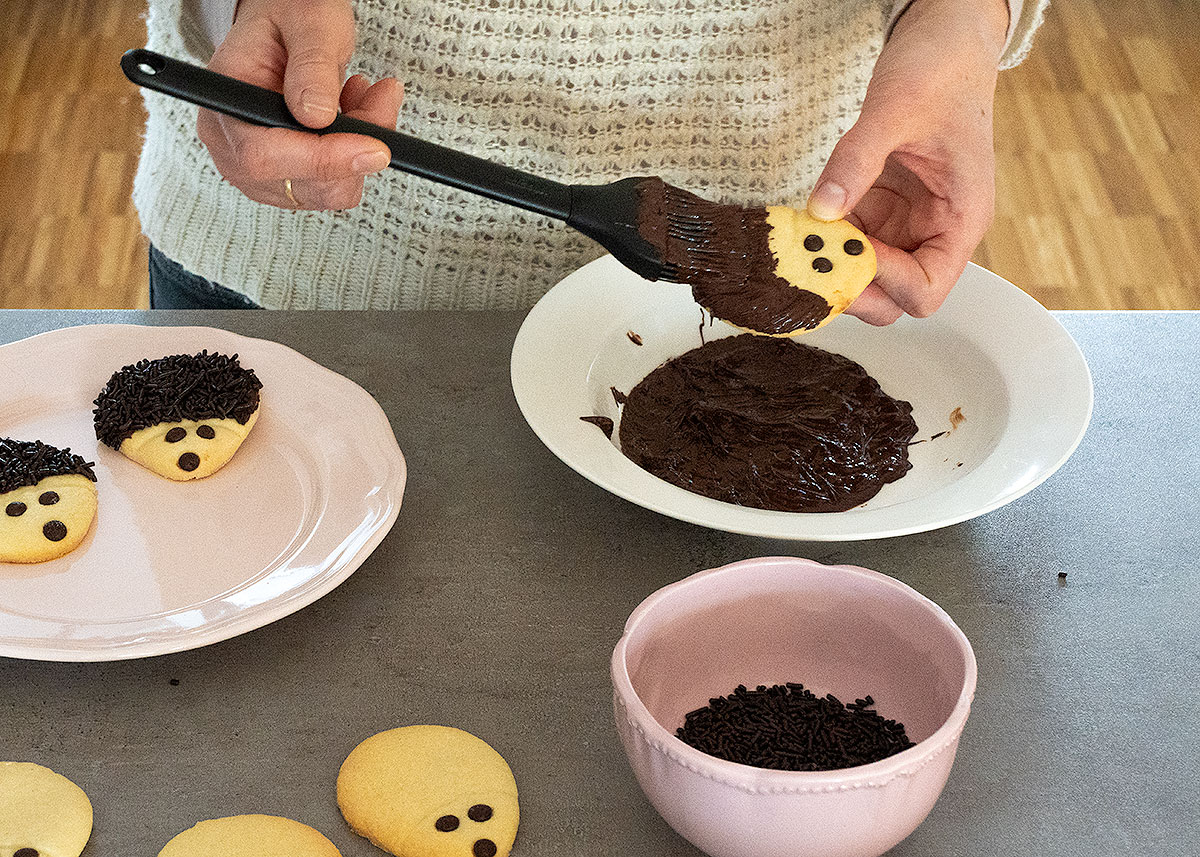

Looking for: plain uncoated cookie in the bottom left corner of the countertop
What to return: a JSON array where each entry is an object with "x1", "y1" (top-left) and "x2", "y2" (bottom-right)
[{"x1": 0, "y1": 762, "x2": 91, "y2": 857}]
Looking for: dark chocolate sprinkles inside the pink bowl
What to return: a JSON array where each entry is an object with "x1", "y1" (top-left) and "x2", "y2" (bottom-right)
[{"x1": 676, "y1": 682, "x2": 914, "y2": 771}]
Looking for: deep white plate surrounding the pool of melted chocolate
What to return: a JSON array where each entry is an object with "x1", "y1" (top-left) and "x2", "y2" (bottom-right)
[{"x1": 512, "y1": 257, "x2": 1092, "y2": 541}]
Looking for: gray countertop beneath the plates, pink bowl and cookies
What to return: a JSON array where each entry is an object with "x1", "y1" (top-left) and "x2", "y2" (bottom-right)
[{"x1": 0, "y1": 311, "x2": 1200, "y2": 857}]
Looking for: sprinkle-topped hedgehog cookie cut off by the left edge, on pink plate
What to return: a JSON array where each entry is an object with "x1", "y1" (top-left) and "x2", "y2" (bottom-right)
[{"x1": 0, "y1": 438, "x2": 97, "y2": 564}]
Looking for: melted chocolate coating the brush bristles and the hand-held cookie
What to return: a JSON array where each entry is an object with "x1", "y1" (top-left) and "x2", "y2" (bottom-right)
[{"x1": 637, "y1": 179, "x2": 833, "y2": 334}]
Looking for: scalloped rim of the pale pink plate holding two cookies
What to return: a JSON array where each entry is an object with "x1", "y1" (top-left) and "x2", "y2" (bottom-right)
[{"x1": 0, "y1": 322, "x2": 408, "y2": 663}]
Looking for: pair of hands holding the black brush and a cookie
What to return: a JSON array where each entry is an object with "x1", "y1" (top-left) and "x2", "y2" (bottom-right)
[{"x1": 197, "y1": 0, "x2": 1008, "y2": 324}]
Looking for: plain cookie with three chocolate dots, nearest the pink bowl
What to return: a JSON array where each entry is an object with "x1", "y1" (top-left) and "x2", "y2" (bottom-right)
[{"x1": 337, "y1": 726, "x2": 518, "y2": 857}]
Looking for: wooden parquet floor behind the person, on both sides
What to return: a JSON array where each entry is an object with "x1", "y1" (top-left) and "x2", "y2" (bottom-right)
[{"x1": 0, "y1": 0, "x2": 1200, "y2": 310}]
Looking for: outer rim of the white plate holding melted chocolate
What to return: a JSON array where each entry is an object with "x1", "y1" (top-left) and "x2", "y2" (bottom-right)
[{"x1": 510, "y1": 256, "x2": 1096, "y2": 543}]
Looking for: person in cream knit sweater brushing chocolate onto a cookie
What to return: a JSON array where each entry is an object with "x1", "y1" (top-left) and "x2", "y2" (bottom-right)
[{"x1": 133, "y1": 0, "x2": 1046, "y2": 316}]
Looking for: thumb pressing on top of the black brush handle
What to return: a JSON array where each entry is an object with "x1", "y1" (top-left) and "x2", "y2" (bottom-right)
[{"x1": 276, "y1": 0, "x2": 354, "y2": 128}]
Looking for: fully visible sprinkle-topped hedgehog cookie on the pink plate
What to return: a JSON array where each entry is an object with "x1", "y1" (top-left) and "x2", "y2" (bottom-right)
[{"x1": 94, "y1": 350, "x2": 263, "y2": 481}]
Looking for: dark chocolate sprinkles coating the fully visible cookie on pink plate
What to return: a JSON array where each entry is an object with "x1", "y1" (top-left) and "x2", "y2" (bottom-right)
[{"x1": 94, "y1": 350, "x2": 263, "y2": 449}]
